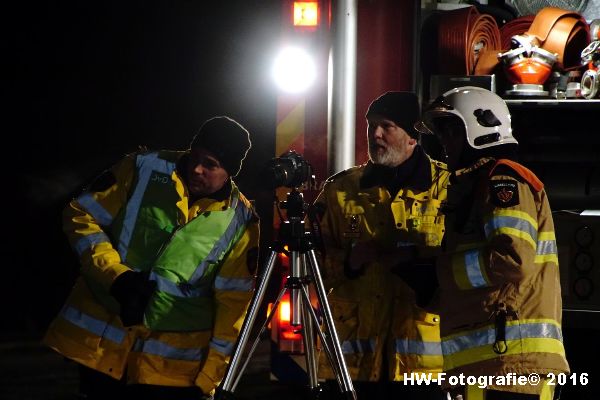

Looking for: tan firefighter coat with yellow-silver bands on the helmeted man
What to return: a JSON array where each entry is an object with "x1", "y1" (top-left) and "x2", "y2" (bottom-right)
[{"x1": 437, "y1": 159, "x2": 569, "y2": 393}]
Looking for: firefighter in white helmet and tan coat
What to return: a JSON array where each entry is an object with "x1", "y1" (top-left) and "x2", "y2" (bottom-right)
[{"x1": 417, "y1": 87, "x2": 569, "y2": 400}]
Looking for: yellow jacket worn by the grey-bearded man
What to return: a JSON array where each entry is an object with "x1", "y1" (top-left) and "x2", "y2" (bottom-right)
[{"x1": 315, "y1": 153, "x2": 449, "y2": 381}]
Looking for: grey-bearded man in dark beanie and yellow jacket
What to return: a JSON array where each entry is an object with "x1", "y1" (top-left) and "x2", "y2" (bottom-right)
[{"x1": 315, "y1": 92, "x2": 449, "y2": 399}]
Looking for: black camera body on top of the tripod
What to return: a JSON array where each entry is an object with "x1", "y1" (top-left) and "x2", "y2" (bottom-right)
[{"x1": 267, "y1": 150, "x2": 314, "y2": 189}]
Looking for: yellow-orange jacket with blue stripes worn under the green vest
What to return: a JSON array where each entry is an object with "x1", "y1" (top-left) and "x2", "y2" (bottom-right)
[{"x1": 44, "y1": 151, "x2": 259, "y2": 393}]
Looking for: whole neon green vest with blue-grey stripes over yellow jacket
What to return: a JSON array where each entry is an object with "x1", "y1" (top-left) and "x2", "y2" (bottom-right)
[{"x1": 94, "y1": 151, "x2": 252, "y2": 331}]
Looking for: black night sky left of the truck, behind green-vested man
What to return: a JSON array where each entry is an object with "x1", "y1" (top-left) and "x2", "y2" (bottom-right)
[{"x1": 5, "y1": 0, "x2": 281, "y2": 339}]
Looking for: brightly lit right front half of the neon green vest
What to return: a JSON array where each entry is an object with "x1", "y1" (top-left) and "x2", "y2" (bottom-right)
[{"x1": 144, "y1": 180, "x2": 252, "y2": 331}]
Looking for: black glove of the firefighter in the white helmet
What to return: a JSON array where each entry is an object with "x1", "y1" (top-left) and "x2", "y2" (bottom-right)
[{"x1": 392, "y1": 263, "x2": 439, "y2": 308}]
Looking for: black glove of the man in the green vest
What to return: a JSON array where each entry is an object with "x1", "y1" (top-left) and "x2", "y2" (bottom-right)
[{"x1": 110, "y1": 271, "x2": 156, "y2": 326}]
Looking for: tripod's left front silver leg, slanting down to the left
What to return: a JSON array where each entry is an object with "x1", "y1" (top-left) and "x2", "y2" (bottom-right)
[{"x1": 215, "y1": 250, "x2": 277, "y2": 399}]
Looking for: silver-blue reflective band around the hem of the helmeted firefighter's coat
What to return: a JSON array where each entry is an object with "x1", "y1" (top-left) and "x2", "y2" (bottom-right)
[{"x1": 442, "y1": 322, "x2": 562, "y2": 355}]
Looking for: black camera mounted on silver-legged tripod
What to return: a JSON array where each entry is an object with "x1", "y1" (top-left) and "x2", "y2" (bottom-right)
[{"x1": 215, "y1": 150, "x2": 356, "y2": 400}]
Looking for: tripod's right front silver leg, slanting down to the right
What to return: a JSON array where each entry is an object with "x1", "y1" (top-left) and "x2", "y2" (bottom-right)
[{"x1": 307, "y1": 250, "x2": 356, "y2": 400}]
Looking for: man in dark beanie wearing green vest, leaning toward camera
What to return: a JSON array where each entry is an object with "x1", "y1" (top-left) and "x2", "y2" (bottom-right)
[{"x1": 44, "y1": 116, "x2": 259, "y2": 400}]
